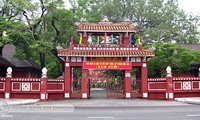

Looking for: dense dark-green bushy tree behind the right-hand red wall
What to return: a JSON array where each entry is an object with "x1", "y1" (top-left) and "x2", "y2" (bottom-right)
[{"x1": 148, "y1": 43, "x2": 200, "y2": 77}]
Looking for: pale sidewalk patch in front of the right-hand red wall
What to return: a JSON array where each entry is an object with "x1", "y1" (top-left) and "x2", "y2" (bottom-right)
[{"x1": 175, "y1": 97, "x2": 200, "y2": 105}]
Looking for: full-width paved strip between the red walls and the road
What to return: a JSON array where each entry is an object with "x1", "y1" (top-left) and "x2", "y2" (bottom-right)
[{"x1": 0, "y1": 97, "x2": 200, "y2": 107}]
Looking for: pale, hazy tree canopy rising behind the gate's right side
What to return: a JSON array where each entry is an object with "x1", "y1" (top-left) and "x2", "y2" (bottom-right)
[{"x1": 89, "y1": 0, "x2": 199, "y2": 44}]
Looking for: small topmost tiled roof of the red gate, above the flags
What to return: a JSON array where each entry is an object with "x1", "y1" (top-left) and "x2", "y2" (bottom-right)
[{"x1": 77, "y1": 22, "x2": 136, "y2": 32}]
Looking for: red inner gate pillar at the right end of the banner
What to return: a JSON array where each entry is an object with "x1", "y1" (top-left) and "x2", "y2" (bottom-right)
[{"x1": 124, "y1": 70, "x2": 132, "y2": 98}]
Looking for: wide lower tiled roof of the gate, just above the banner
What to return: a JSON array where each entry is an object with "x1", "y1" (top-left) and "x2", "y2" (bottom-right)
[{"x1": 58, "y1": 48, "x2": 154, "y2": 57}]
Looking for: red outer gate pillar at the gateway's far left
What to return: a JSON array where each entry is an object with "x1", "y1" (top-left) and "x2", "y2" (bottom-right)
[{"x1": 64, "y1": 62, "x2": 71, "y2": 98}]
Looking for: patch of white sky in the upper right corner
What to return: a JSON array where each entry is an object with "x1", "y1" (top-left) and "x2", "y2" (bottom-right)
[{"x1": 178, "y1": 0, "x2": 200, "y2": 15}]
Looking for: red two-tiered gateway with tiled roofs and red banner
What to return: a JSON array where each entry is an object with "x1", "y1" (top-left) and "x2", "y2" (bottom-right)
[{"x1": 58, "y1": 22, "x2": 154, "y2": 98}]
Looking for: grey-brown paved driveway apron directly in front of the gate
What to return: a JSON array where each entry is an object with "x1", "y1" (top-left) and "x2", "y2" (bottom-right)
[{"x1": 35, "y1": 98, "x2": 189, "y2": 107}]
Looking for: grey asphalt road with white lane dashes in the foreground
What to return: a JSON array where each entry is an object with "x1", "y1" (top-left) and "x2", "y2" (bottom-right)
[{"x1": 4, "y1": 105, "x2": 200, "y2": 120}]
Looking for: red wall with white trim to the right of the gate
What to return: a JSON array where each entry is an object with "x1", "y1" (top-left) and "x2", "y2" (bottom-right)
[{"x1": 148, "y1": 67, "x2": 200, "y2": 100}]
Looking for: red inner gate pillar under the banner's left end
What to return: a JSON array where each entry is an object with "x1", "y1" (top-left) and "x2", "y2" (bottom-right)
[{"x1": 81, "y1": 69, "x2": 89, "y2": 99}]
